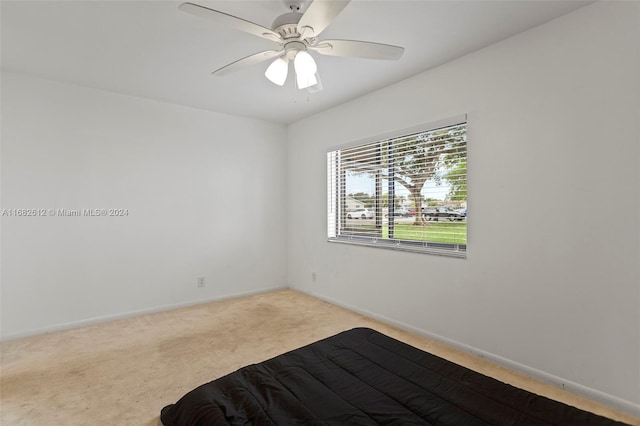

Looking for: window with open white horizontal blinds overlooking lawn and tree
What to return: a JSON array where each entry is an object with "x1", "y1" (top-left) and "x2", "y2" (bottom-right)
[{"x1": 327, "y1": 118, "x2": 467, "y2": 257}]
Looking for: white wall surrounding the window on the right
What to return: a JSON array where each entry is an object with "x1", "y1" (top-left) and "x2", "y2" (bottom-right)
[{"x1": 288, "y1": 2, "x2": 640, "y2": 413}]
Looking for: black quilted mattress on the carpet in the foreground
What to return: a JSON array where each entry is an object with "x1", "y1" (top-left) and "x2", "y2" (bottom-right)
[{"x1": 160, "y1": 328, "x2": 623, "y2": 426}]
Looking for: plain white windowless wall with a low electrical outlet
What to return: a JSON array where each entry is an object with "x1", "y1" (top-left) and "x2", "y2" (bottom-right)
[{"x1": 1, "y1": 73, "x2": 287, "y2": 339}]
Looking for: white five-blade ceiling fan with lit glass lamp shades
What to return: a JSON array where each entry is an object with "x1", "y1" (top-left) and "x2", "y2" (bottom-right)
[{"x1": 179, "y1": 0, "x2": 404, "y2": 91}]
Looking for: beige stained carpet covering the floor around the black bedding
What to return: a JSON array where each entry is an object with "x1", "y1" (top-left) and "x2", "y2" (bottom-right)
[{"x1": 0, "y1": 290, "x2": 640, "y2": 426}]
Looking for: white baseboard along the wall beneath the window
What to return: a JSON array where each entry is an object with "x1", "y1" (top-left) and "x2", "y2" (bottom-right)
[{"x1": 304, "y1": 288, "x2": 640, "y2": 417}]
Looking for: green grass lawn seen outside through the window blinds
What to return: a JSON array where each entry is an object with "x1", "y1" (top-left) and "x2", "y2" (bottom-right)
[{"x1": 349, "y1": 221, "x2": 467, "y2": 244}]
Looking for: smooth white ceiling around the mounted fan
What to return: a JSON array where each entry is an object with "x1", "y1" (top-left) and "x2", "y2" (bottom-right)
[{"x1": 1, "y1": 0, "x2": 591, "y2": 123}]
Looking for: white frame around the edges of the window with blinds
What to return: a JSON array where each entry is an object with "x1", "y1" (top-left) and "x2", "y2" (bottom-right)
[{"x1": 326, "y1": 114, "x2": 469, "y2": 259}]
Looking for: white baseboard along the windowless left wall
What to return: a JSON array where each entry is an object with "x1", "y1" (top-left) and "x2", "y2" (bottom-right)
[{"x1": 0, "y1": 286, "x2": 288, "y2": 342}]
